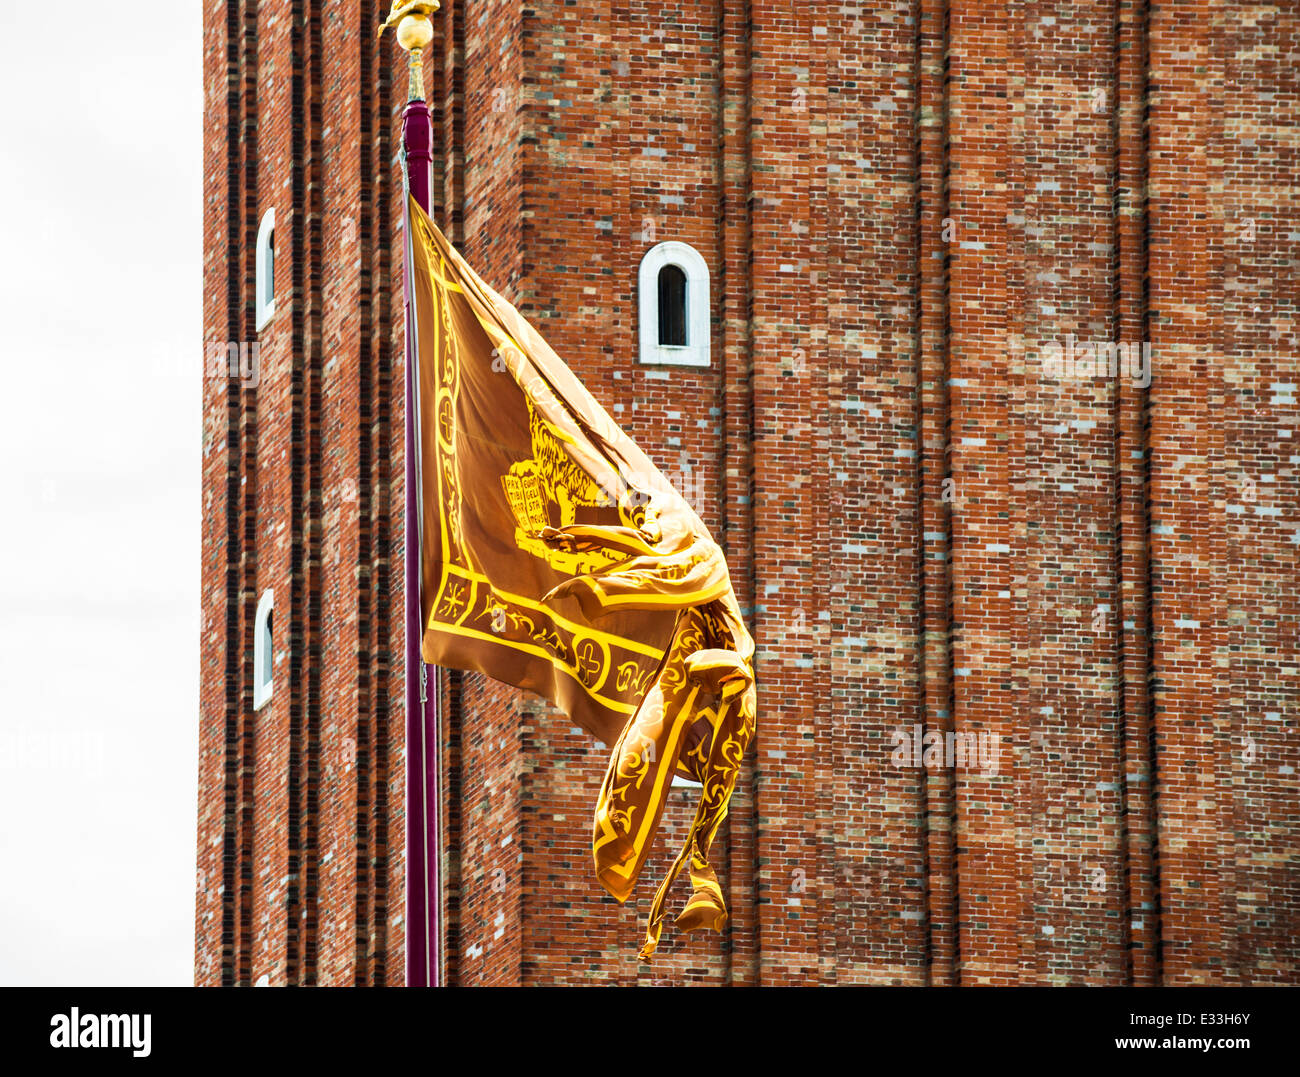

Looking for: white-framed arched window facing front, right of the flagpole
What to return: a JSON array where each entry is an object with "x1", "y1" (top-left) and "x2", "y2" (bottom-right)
[{"x1": 637, "y1": 241, "x2": 710, "y2": 367}]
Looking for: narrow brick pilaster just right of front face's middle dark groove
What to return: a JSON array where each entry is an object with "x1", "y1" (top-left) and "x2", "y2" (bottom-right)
[{"x1": 949, "y1": 0, "x2": 1021, "y2": 983}]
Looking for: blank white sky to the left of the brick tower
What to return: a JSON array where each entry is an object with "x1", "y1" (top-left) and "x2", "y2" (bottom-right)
[{"x1": 0, "y1": 0, "x2": 203, "y2": 985}]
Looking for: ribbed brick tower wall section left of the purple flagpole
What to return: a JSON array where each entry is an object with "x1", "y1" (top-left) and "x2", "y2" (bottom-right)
[{"x1": 195, "y1": 0, "x2": 404, "y2": 985}]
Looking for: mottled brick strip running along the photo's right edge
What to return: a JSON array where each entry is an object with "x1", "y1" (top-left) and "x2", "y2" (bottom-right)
[{"x1": 1210, "y1": 0, "x2": 1300, "y2": 983}]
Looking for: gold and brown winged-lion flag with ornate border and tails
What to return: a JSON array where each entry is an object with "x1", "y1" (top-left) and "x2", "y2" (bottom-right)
[{"x1": 407, "y1": 199, "x2": 755, "y2": 960}]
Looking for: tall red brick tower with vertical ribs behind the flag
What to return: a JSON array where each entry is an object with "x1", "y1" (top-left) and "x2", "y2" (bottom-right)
[{"x1": 195, "y1": 0, "x2": 1300, "y2": 985}]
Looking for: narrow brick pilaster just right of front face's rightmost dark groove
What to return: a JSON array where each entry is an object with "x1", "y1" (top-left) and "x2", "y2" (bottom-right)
[{"x1": 1149, "y1": 4, "x2": 1227, "y2": 985}]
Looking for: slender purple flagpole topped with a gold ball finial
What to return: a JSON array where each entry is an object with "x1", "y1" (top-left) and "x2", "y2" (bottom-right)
[{"x1": 387, "y1": 0, "x2": 442, "y2": 987}]
